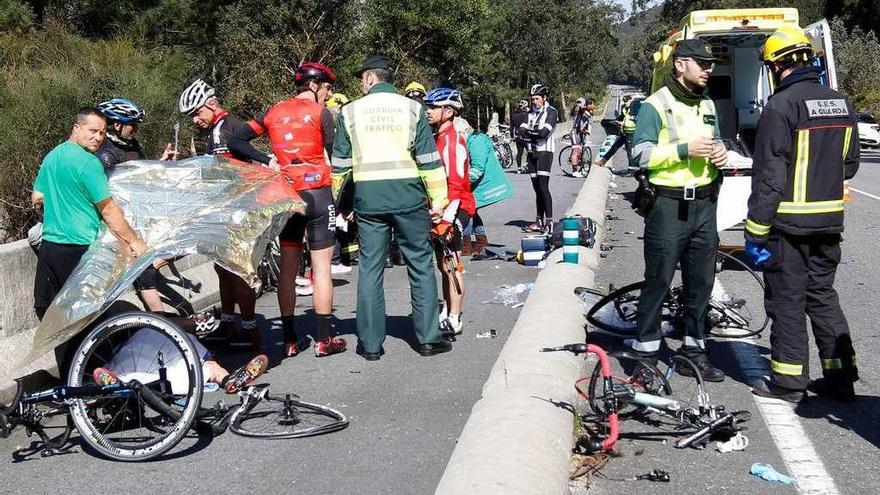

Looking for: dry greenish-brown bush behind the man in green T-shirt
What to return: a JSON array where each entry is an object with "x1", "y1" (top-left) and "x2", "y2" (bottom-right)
[{"x1": 0, "y1": 25, "x2": 192, "y2": 241}]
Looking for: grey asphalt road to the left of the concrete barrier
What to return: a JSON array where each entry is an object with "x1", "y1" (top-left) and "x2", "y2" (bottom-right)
[{"x1": 0, "y1": 122, "x2": 583, "y2": 495}]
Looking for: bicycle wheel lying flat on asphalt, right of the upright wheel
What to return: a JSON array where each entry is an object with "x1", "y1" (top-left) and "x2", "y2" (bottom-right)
[{"x1": 229, "y1": 385, "x2": 348, "y2": 439}]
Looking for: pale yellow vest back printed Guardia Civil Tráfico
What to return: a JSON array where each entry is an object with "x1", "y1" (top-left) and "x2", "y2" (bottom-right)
[{"x1": 342, "y1": 93, "x2": 426, "y2": 182}]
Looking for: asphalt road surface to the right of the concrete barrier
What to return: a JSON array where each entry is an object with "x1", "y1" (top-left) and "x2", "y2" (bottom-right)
[{"x1": 590, "y1": 142, "x2": 880, "y2": 494}]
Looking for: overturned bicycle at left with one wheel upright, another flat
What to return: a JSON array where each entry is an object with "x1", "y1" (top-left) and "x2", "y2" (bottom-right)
[{"x1": 0, "y1": 312, "x2": 348, "y2": 461}]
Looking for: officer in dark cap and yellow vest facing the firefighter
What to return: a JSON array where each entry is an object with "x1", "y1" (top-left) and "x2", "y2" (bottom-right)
[{"x1": 631, "y1": 40, "x2": 727, "y2": 382}]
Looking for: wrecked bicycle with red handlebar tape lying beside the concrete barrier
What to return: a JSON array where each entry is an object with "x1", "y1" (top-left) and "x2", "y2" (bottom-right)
[{"x1": 541, "y1": 343, "x2": 751, "y2": 453}]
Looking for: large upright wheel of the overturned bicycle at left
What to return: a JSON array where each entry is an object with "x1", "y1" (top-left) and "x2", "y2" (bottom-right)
[{"x1": 67, "y1": 312, "x2": 202, "y2": 461}]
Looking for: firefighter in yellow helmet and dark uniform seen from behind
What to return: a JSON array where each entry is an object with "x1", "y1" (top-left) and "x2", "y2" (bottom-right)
[{"x1": 745, "y1": 27, "x2": 859, "y2": 402}]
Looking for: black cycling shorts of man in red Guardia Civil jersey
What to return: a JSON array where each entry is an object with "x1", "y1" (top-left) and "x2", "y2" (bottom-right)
[{"x1": 279, "y1": 187, "x2": 336, "y2": 251}]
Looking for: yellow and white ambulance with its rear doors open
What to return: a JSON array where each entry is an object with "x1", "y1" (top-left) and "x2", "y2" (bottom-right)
[{"x1": 651, "y1": 8, "x2": 837, "y2": 230}]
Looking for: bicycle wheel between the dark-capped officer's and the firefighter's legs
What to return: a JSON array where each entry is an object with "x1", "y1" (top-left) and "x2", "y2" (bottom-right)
[{"x1": 707, "y1": 251, "x2": 770, "y2": 338}]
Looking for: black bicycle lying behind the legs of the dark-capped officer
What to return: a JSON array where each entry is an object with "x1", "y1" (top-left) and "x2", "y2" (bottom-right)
[{"x1": 575, "y1": 248, "x2": 770, "y2": 338}]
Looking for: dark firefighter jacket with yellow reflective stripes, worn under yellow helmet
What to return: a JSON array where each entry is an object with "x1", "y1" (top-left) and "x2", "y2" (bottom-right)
[{"x1": 745, "y1": 68, "x2": 859, "y2": 242}]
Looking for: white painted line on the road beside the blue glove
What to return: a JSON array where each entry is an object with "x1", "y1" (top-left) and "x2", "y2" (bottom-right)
[{"x1": 717, "y1": 278, "x2": 840, "y2": 495}]
